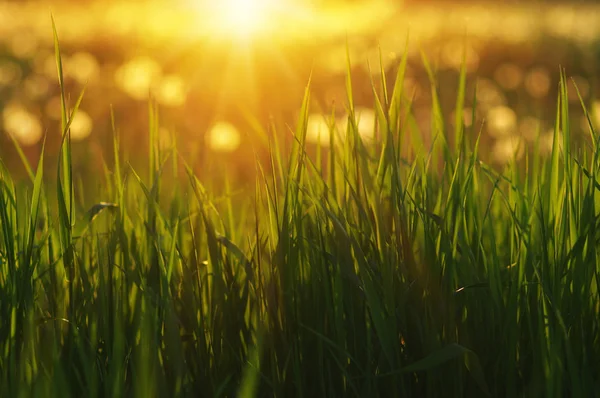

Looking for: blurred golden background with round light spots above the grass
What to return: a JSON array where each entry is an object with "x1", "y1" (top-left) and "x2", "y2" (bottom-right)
[{"x1": 0, "y1": 0, "x2": 600, "y2": 177}]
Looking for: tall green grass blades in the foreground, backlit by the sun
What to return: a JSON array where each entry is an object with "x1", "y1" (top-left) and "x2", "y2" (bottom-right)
[{"x1": 0, "y1": 25, "x2": 600, "y2": 397}]
